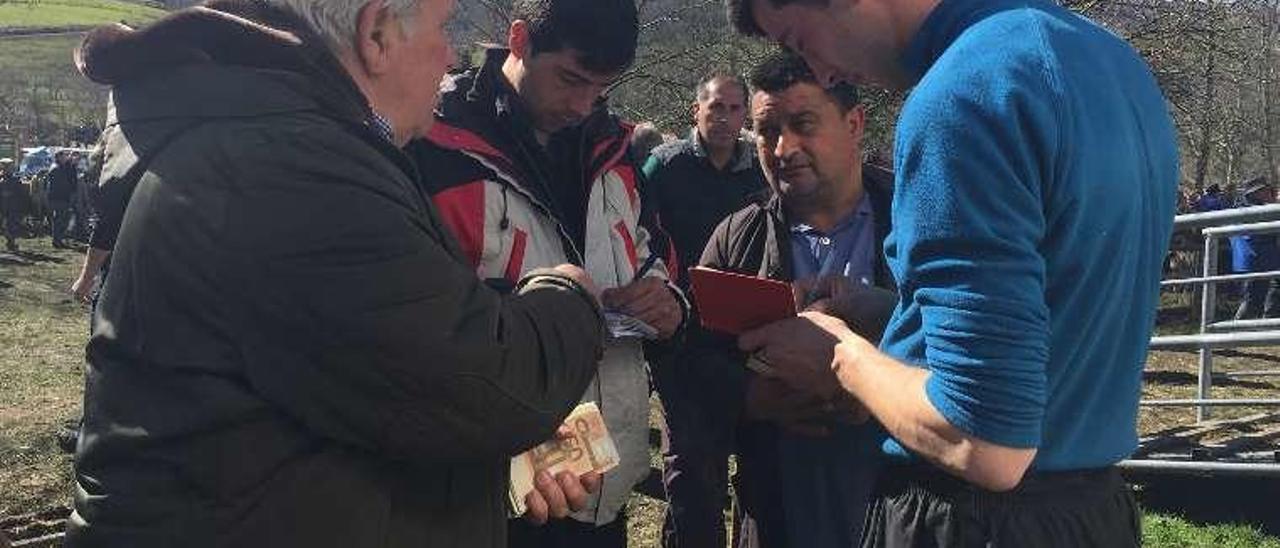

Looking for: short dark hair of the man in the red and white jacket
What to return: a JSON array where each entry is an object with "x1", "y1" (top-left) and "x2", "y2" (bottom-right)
[{"x1": 511, "y1": 0, "x2": 640, "y2": 74}]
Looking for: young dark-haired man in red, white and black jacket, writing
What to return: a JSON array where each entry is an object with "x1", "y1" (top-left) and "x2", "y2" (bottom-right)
[{"x1": 408, "y1": 0, "x2": 689, "y2": 547}]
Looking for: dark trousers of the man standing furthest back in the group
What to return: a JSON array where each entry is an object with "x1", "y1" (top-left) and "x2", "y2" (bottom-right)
[{"x1": 654, "y1": 359, "x2": 736, "y2": 548}]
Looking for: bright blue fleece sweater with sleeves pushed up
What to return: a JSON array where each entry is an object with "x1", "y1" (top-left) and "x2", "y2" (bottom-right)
[{"x1": 882, "y1": 0, "x2": 1178, "y2": 470}]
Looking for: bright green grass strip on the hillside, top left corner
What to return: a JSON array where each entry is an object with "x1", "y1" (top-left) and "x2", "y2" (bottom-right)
[{"x1": 0, "y1": 0, "x2": 164, "y2": 28}]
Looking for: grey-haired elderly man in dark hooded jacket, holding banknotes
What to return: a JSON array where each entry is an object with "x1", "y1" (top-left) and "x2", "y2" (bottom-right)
[{"x1": 68, "y1": 0, "x2": 603, "y2": 547}]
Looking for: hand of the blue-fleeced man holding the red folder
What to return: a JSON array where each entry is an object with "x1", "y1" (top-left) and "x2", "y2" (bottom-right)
[{"x1": 737, "y1": 312, "x2": 858, "y2": 401}]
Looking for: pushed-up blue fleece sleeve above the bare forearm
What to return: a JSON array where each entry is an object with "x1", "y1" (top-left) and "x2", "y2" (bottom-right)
[{"x1": 892, "y1": 82, "x2": 1057, "y2": 448}]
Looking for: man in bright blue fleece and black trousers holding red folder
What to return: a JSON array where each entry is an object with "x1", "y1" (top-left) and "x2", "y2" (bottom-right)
[{"x1": 727, "y1": 0, "x2": 1178, "y2": 547}]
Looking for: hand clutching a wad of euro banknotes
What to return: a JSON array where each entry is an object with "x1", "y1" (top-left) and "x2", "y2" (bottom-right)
[{"x1": 508, "y1": 402, "x2": 618, "y2": 524}]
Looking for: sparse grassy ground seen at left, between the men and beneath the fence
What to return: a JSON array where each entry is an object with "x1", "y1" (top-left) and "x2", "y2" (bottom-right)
[{"x1": 0, "y1": 238, "x2": 1280, "y2": 548}]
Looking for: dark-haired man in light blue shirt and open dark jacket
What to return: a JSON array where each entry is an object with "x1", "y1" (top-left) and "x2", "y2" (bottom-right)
[{"x1": 699, "y1": 54, "x2": 893, "y2": 548}]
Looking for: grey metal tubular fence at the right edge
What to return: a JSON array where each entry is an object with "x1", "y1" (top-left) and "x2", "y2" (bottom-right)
[{"x1": 1121, "y1": 205, "x2": 1280, "y2": 478}]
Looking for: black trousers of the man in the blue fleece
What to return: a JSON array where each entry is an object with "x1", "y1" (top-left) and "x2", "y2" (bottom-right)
[{"x1": 863, "y1": 465, "x2": 1142, "y2": 548}]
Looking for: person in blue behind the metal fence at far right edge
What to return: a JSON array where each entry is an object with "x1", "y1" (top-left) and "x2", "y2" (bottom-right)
[{"x1": 1230, "y1": 177, "x2": 1280, "y2": 320}]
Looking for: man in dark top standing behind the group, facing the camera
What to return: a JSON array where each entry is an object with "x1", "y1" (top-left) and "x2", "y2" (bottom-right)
[{"x1": 644, "y1": 74, "x2": 768, "y2": 547}]
